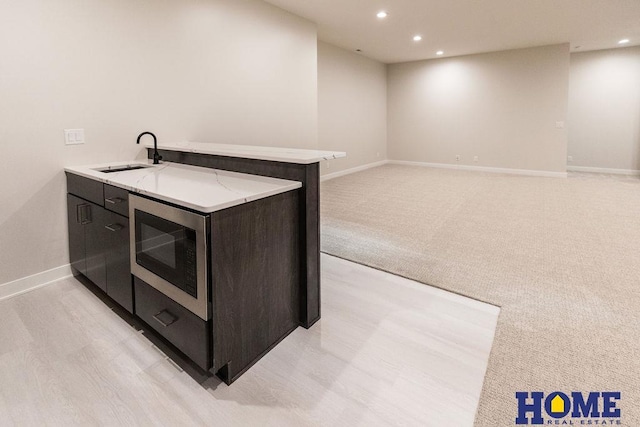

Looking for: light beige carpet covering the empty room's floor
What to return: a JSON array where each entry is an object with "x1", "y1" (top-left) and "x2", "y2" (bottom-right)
[{"x1": 321, "y1": 165, "x2": 640, "y2": 426}]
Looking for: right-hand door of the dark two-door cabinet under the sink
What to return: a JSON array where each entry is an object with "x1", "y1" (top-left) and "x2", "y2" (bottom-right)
[{"x1": 84, "y1": 203, "x2": 109, "y2": 291}]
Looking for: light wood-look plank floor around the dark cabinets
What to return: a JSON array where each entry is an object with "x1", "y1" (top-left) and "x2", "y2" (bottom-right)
[{"x1": 0, "y1": 255, "x2": 499, "y2": 426}]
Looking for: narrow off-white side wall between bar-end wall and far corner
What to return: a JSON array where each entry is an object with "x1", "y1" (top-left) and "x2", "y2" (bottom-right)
[{"x1": 318, "y1": 42, "x2": 387, "y2": 174}]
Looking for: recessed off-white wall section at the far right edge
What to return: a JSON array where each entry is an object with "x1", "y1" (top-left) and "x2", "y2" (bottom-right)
[{"x1": 568, "y1": 46, "x2": 640, "y2": 170}]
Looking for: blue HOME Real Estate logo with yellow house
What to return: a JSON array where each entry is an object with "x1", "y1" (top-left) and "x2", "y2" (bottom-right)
[{"x1": 516, "y1": 391, "x2": 622, "y2": 426}]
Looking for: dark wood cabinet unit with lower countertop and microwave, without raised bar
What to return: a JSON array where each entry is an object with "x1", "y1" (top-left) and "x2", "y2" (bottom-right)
[{"x1": 65, "y1": 162, "x2": 302, "y2": 384}]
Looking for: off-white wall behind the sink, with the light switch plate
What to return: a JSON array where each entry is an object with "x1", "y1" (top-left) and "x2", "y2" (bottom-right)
[{"x1": 0, "y1": 0, "x2": 317, "y2": 284}]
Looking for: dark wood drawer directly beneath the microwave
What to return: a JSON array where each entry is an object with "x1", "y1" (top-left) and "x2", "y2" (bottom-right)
[{"x1": 133, "y1": 276, "x2": 211, "y2": 370}]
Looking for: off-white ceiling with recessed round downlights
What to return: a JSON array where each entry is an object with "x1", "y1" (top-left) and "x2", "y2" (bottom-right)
[{"x1": 265, "y1": 0, "x2": 640, "y2": 63}]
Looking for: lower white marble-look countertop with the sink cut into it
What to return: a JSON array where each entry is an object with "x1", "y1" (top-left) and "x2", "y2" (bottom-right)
[{"x1": 65, "y1": 161, "x2": 302, "y2": 213}]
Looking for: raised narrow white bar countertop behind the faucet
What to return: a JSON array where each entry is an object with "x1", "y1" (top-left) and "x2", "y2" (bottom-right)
[{"x1": 144, "y1": 141, "x2": 347, "y2": 165}]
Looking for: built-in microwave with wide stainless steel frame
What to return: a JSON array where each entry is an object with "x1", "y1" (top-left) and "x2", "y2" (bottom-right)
[{"x1": 129, "y1": 194, "x2": 211, "y2": 320}]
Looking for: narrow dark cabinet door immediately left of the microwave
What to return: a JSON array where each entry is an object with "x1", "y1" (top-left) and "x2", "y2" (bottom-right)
[{"x1": 104, "y1": 212, "x2": 133, "y2": 313}]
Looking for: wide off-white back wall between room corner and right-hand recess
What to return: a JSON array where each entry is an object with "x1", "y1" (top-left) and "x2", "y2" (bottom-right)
[{"x1": 387, "y1": 44, "x2": 569, "y2": 172}]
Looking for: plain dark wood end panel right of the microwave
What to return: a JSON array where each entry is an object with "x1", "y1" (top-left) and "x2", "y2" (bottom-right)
[{"x1": 211, "y1": 190, "x2": 301, "y2": 384}]
